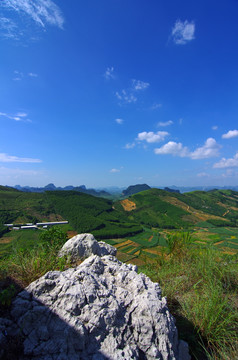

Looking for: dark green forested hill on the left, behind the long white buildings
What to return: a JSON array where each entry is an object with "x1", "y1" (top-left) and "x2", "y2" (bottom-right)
[{"x1": 0, "y1": 187, "x2": 142, "y2": 238}]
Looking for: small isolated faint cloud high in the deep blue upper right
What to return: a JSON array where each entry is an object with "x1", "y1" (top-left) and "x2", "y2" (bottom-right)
[{"x1": 171, "y1": 20, "x2": 195, "y2": 45}]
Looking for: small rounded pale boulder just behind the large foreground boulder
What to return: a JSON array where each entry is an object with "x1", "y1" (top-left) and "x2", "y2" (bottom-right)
[{"x1": 59, "y1": 234, "x2": 116, "y2": 260}]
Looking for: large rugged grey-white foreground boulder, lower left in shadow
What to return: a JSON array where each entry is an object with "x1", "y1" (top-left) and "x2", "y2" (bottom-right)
[{"x1": 11, "y1": 253, "x2": 190, "y2": 360}]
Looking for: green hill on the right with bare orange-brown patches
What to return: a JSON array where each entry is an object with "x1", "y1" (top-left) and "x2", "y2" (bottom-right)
[{"x1": 115, "y1": 189, "x2": 238, "y2": 228}]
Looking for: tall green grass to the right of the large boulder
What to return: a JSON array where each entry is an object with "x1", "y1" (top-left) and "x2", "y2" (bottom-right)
[{"x1": 140, "y1": 235, "x2": 238, "y2": 360}]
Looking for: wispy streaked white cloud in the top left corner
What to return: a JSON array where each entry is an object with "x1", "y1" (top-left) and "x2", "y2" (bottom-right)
[{"x1": 2, "y1": 0, "x2": 64, "y2": 29}]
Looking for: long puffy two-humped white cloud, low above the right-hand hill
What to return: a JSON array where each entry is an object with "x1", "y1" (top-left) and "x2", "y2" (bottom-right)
[{"x1": 154, "y1": 138, "x2": 220, "y2": 160}]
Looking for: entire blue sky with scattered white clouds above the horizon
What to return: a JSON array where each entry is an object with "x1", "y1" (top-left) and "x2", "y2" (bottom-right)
[{"x1": 0, "y1": 0, "x2": 238, "y2": 187}]
